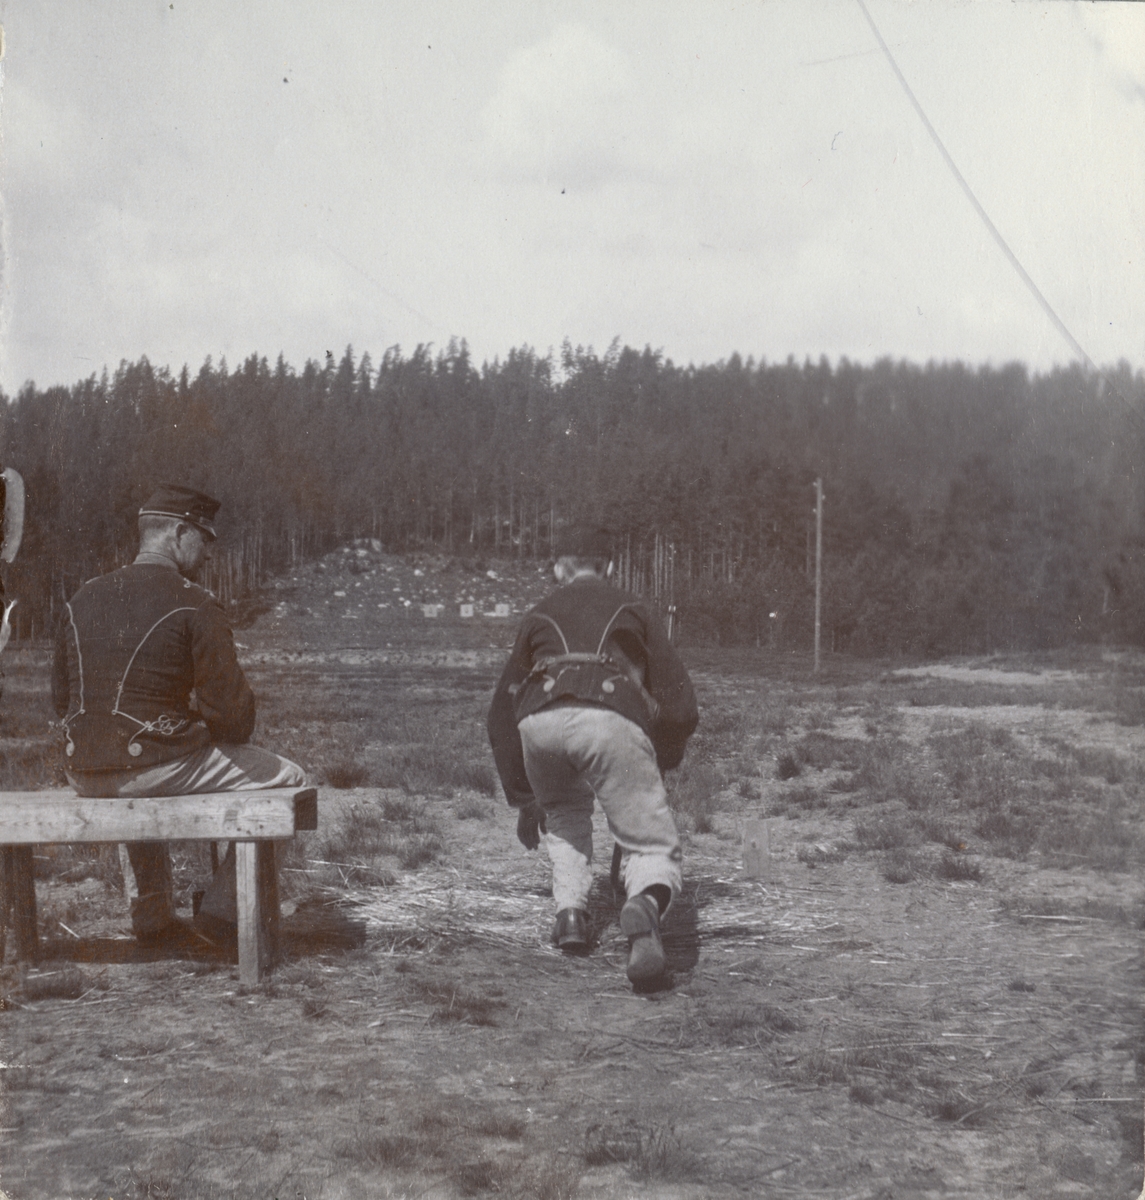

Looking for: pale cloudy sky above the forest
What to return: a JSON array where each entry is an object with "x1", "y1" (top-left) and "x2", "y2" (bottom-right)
[{"x1": 0, "y1": 0, "x2": 1145, "y2": 395}]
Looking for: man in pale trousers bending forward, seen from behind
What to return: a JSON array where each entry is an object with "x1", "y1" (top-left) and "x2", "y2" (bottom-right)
[{"x1": 488, "y1": 528, "x2": 699, "y2": 985}]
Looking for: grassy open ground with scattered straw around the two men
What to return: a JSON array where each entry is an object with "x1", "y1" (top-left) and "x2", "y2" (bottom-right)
[{"x1": 0, "y1": 556, "x2": 1145, "y2": 1200}]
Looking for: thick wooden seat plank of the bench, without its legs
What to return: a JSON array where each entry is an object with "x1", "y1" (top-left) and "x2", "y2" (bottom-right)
[{"x1": 0, "y1": 787, "x2": 318, "y2": 846}]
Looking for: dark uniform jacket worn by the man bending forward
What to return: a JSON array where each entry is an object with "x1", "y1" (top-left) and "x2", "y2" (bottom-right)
[{"x1": 488, "y1": 578, "x2": 700, "y2": 808}]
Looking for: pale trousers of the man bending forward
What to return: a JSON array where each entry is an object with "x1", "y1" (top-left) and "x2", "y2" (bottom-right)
[{"x1": 517, "y1": 704, "x2": 683, "y2": 912}]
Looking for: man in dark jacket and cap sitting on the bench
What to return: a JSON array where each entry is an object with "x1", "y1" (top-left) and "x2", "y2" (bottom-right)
[{"x1": 52, "y1": 485, "x2": 306, "y2": 941}]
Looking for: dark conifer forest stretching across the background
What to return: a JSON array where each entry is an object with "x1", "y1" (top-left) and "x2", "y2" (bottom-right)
[{"x1": 0, "y1": 342, "x2": 1145, "y2": 654}]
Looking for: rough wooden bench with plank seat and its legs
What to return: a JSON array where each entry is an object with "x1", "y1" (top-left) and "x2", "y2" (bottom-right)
[{"x1": 0, "y1": 787, "x2": 318, "y2": 984}]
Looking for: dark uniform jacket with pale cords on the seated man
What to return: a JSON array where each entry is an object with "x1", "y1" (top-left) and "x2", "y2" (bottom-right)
[{"x1": 52, "y1": 563, "x2": 254, "y2": 770}]
